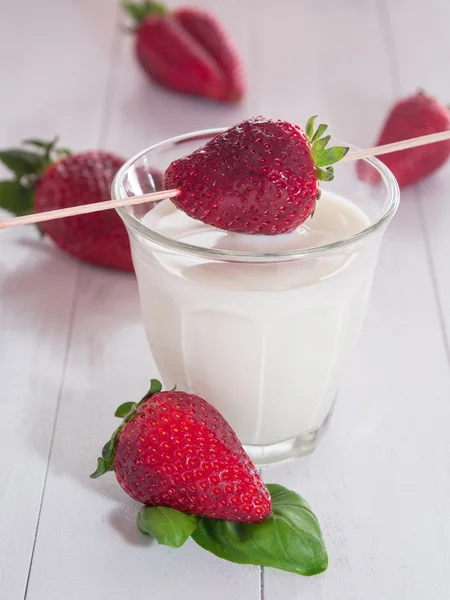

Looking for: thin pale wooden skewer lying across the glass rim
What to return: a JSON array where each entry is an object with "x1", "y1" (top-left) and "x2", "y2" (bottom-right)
[{"x1": 0, "y1": 130, "x2": 450, "y2": 229}]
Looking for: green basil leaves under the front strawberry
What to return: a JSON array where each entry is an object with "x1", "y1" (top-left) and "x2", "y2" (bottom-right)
[{"x1": 137, "y1": 483, "x2": 328, "y2": 576}]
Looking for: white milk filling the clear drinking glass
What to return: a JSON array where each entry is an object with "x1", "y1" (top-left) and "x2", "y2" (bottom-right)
[{"x1": 132, "y1": 193, "x2": 378, "y2": 445}]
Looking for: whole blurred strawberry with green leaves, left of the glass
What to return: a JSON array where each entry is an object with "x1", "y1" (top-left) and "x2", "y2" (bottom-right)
[{"x1": 0, "y1": 140, "x2": 133, "y2": 271}]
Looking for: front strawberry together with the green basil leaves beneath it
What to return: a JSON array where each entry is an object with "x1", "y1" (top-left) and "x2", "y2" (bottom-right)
[{"x1": 91, "y1": 380, "x2": 328, "y2": 576}]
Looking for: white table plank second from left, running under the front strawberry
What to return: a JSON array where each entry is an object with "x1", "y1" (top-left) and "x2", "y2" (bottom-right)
[{"x1": 27, "y1": 0, "x2": 260, "y2": 600}]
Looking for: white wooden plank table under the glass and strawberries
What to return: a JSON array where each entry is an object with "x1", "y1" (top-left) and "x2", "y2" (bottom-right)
[{"x1": 0, "y1": 0, "x2": 450, "y2": 600}]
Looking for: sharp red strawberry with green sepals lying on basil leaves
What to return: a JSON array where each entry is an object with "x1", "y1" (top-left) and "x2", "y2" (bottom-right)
[{"x1": 91, "y1": 380, "x2": 271, "y2": 523}]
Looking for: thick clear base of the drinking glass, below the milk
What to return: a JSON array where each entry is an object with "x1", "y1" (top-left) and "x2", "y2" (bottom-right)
[{"x1": 244, "y1": 411, "x2": 332, "y2": 467}]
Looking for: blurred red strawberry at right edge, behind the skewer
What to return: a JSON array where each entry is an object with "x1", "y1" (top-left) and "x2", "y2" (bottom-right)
[{"x1": 357, "y1": 92, "x2": 450, "y2": 187}]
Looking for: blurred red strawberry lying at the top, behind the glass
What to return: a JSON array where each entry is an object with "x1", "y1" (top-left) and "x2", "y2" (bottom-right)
[{"x1": 124, "y1": 1, "x2": 244, "y2": 102}]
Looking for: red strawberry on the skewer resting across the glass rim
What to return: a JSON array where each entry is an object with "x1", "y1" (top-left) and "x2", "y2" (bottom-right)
[{"x1": 165, "y1": 117, "x2": 348, "y2": 235}]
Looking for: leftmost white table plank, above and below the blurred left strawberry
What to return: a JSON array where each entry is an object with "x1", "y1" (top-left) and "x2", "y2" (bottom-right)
[{"x1": 0, "y1": 0, "x2": 115, "y2": 600}]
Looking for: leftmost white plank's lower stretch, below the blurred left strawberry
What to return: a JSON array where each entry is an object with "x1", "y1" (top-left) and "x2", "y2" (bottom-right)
[{"x1": 0, "y1": 230, "x2": 78, "y2": 600}]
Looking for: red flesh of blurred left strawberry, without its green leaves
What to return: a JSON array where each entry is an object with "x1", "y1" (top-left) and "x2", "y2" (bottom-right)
[{"x1": 34, "y1": 151, "x2": 133, "y2": 271}]
